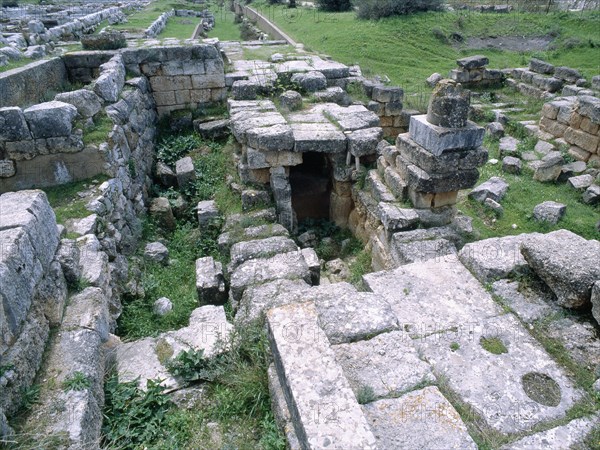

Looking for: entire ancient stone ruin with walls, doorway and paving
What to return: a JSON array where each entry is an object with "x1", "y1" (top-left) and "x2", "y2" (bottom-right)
[{"x1": 0, "y1": 4, "x2": 600, "y2": 450}]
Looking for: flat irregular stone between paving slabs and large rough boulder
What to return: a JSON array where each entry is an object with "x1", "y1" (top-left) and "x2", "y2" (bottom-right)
[{"x1": 492, "y1": 280, "x2": 556, "y2": 323}]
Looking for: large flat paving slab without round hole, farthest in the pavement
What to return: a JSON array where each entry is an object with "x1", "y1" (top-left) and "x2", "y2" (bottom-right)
[{"x1": 363, "y1": 255, "x2": 502, "y2": 337}]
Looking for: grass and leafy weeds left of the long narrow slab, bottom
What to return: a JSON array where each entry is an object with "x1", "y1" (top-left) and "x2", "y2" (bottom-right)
[{"x1": 103, "y1": 326, "x2": 285, "y2": 450}]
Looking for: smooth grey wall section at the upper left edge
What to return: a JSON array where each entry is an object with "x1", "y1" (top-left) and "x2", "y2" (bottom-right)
[{"x1": 0, "y1": 58, "x2": 67, "y2": 108}]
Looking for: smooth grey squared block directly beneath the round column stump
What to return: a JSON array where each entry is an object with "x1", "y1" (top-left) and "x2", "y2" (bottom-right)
[{"x1": 408, "y1": 114, "x2": 485, "y2": 155}]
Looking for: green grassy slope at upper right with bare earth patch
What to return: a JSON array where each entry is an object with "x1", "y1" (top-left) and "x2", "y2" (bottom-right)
[{"x1": 263, "y1": 6, "x2": 600, "y2": 92}]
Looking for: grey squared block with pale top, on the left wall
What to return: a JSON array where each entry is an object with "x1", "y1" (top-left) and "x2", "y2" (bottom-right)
[{"x1": 23, "y1": 101, "x2": 77, "y2": 139}]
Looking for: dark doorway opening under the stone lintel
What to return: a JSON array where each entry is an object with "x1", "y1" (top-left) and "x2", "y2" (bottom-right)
[{"x1": 290, "y1": 152, "x2": 331, "y2": 221}]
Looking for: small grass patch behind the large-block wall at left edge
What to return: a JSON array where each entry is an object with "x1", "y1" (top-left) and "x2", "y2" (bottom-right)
[{"x1": 43, "y1": 175, "x2": 108, "y2": 225}]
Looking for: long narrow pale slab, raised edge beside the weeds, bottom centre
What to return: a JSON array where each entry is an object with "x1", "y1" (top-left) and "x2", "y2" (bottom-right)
[{"x1": 267, "y1": 303, "x2": 376, "y2": 450}]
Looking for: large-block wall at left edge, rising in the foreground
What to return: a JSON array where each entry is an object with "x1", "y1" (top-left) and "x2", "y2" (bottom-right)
[{"x1": 0, "y1": 191, "x2": 67, "y2": 415}]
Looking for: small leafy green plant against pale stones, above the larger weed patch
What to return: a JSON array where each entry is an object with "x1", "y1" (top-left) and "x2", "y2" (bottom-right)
[{"x1": 167, "y1": 349, "x2": 226, "y2": 381}]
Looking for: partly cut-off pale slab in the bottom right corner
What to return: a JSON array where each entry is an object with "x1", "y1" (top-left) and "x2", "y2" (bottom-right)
[{"x1": 500, "y1": 415, "x2": 600, "y2": 450}]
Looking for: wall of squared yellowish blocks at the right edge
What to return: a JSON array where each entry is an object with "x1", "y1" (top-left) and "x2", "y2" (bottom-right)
[{"x1": 540, "y1": 95, "x2": 600, "y2": 167}]
